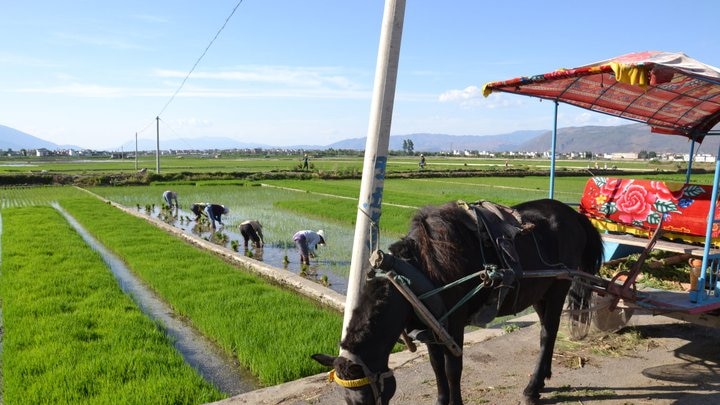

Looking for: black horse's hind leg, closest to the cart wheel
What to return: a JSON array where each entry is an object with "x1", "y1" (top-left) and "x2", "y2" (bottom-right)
[{"x1": 523, "y1": 289, "x2": 567, "y2": 404}]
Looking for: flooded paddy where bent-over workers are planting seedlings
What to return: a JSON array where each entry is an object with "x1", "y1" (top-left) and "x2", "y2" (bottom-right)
[{"x1": 95, "y1": 185, "x2": 408, "y2": 295}]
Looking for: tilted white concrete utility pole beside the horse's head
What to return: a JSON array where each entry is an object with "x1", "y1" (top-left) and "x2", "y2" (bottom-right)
[{"x1": 342, "y1": 0, "x2": 405, "y2": 338}]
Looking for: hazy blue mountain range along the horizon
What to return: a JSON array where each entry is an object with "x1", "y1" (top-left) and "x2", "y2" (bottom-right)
[{"x1": 0, "y1": 124, "x2": 720, "y2": 155}]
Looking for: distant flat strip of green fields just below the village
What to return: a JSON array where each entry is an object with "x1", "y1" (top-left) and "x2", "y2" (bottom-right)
[{"x1": 0, "y1": 151, "x2": 714, "y2": 174}]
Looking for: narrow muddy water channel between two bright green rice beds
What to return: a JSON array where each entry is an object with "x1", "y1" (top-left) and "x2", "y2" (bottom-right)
[{"x1": 52, "y1": 203, "x2": 261, "y2": 395}]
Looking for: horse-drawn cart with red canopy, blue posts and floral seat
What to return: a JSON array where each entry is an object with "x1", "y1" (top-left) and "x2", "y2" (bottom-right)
[{"x1": 483, "y1": 51, "x2": 720, "y2": 327}]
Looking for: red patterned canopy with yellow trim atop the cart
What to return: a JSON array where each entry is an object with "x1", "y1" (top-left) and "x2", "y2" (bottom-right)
[{"x1": 483, "y1": 51, "x2": 720, "y2": 141}]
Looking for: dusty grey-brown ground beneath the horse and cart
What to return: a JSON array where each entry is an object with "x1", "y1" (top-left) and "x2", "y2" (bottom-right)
[{"x1": 217, "y1": 314, "x2": 720, "y2": 405}]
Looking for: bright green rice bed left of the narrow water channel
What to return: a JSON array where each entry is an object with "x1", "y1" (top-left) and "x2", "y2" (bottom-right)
[{"x1": 0, "y1": 204, "x2": 224, "y2": 404}]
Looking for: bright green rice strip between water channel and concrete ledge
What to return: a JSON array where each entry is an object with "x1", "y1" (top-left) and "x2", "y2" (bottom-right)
[{"x1": 61, "y1": 198, "x2": 342, "y2": 385}]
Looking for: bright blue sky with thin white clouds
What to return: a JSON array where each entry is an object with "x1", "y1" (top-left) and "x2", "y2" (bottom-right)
[{"x1": 0, "y1": 0, "x2": 720, "y2": 149}]
